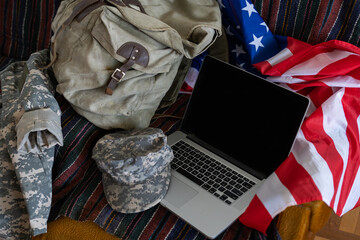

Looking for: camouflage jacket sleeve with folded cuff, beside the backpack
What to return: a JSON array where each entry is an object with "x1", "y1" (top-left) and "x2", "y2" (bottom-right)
[{"x1": 12, "y1": 51, "x2": 63, "y2": 235}]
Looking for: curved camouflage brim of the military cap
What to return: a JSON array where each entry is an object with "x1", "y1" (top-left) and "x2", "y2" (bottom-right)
[{"x1": 102, "y1": 164, "x2": 171, "y2": 213}]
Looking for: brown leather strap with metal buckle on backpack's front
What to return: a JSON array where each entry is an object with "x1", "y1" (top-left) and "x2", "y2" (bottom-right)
[{"x1": 105, "y1": 42, "x2": 149, "y2": 95}]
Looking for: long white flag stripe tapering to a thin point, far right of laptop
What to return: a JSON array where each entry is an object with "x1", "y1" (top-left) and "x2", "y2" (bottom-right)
[{"x1": 321, "y1": 88, "x2": 349, "y2": 212}]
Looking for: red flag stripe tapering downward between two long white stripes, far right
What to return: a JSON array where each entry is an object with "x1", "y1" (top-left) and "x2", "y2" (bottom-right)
[{"x1": 301, "y1": 108, "x2": 344, "y2": 207}]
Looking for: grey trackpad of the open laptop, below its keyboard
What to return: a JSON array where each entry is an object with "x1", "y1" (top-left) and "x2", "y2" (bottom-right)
[{"x1": 165, "y1": 176, "x2": 198, "y2": 208}]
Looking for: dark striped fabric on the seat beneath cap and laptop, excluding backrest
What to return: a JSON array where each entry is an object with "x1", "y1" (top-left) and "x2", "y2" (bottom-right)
[{"x1": 50, "y1": 94, "x2": 280, "y2": 239}]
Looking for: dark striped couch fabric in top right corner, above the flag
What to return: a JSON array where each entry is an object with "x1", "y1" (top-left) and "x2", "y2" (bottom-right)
[{"x1": 253, "y1": 0, "x2": 360, "y2": 46}]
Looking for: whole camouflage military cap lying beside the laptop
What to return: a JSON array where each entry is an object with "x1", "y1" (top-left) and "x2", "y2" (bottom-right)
[{"x1": 93, "y1": 128, "x2": 174, "y2": 213}]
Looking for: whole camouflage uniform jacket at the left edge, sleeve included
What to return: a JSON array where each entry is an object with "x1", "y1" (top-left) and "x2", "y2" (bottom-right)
[{"x1": 0, "y1": 50, "x2": 63, "y2": 240}]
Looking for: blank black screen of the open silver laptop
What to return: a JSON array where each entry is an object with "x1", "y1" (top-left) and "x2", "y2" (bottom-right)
[{"x1": 181, "y1": 57, "x2": 309, "y2": 178}]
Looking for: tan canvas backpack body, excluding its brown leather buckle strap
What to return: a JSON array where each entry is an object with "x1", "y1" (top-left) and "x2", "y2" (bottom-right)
[{"x1": 52, "y1": 0, "x2": 221, "y2": 129}]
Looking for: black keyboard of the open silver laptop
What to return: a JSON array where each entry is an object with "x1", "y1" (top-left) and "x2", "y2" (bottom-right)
[{"x1": 171, "y1": 140, "x2": 255, "y2": 204}]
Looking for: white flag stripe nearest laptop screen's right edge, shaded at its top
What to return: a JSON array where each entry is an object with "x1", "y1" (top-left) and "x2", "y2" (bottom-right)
[{"x1": 292, "y1": 130, "x2": 334, "y2": 205}]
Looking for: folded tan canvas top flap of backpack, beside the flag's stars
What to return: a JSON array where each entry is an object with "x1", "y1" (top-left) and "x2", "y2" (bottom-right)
[{"x1": 116, "y1": 0, "x2": 222, "y2": 59}]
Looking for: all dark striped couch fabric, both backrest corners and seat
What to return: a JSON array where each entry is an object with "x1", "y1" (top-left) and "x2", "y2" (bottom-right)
[{"x1": 0, "y1": 0, "x2": 360, "y2": 239}]
